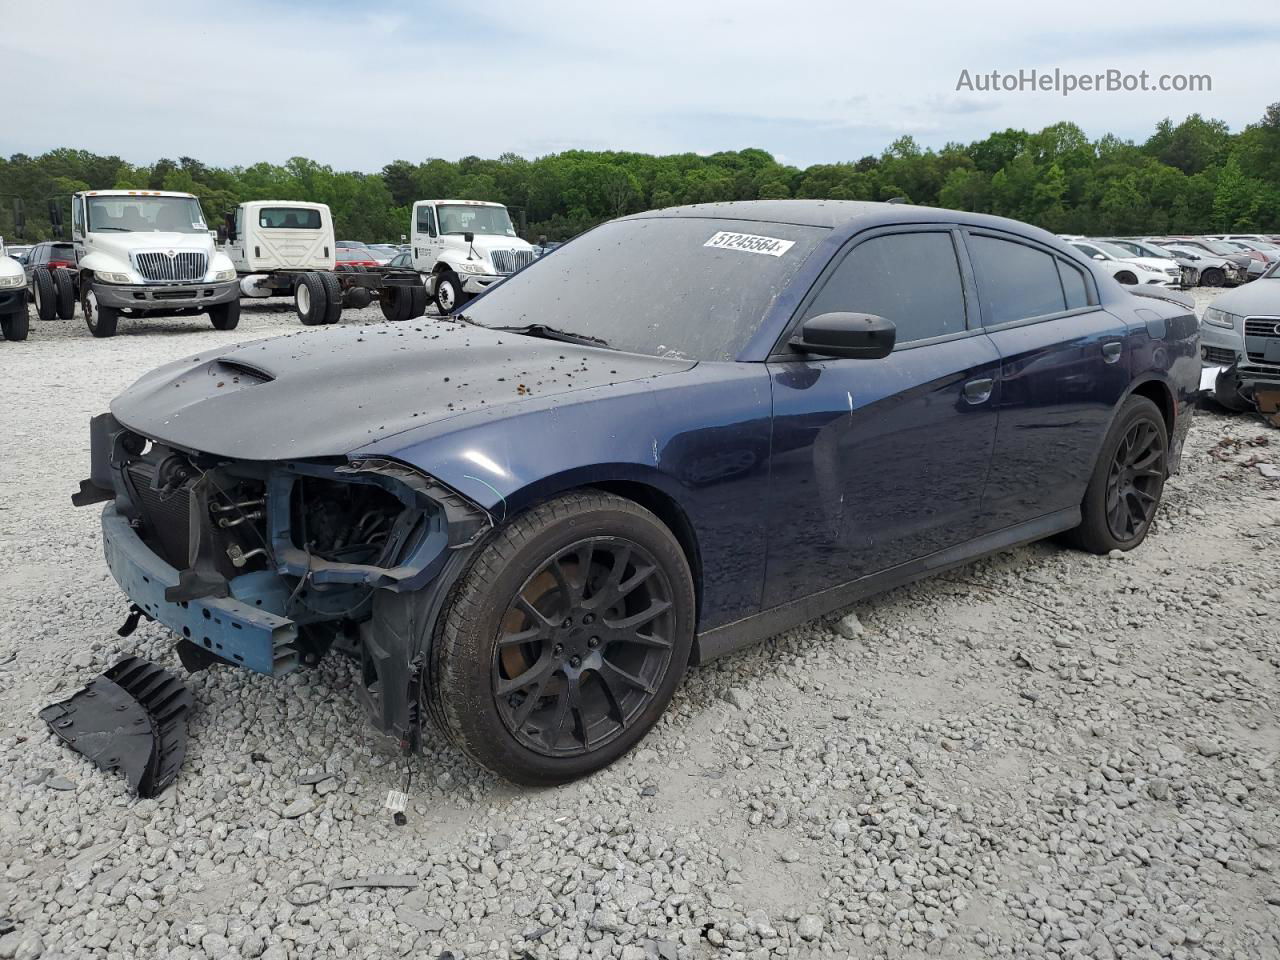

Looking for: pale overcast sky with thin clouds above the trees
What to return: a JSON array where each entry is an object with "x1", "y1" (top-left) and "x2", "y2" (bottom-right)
[{"x1": 0, "y1": 0, "x2": 1280, "y2": 170}]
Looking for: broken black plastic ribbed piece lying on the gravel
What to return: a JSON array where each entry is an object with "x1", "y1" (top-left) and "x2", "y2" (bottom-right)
[{"x1": 40, "y1": 657, "x2": 191, "y2": 797}]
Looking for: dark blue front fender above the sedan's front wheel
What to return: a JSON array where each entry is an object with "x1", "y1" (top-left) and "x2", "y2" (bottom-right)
[{"x1": 352, "y1": 362, "x2": 771, "y2": 630}]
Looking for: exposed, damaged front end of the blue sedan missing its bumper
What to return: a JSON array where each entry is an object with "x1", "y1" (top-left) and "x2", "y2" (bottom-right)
[{"x1": 72, "y1": 413, "x2": 492, "y2": 746}]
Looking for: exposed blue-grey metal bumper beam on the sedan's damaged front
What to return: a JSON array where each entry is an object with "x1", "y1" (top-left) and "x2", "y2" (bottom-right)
[{"x1": 102, "y1": 506, "x2": 298, "y2": 676}]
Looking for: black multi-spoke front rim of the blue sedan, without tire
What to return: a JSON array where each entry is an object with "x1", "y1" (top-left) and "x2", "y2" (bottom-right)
[{"x1": 492, "y1": 536, "x2": 675, "y2": 756}]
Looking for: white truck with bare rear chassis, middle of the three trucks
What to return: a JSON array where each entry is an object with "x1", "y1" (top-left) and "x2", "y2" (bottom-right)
[{"x1": 218, "y1": 200, "x2": 428, "y2": 326}]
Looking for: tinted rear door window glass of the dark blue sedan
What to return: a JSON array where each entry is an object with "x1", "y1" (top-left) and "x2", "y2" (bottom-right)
[{"x1": 969, "y1": 234, "x2": 1066, "y2": 325}]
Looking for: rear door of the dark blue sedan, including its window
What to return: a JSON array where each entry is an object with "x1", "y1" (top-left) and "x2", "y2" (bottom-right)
[{"x1": 965, "y1": 229, "x2": 1130, "y2": 532}]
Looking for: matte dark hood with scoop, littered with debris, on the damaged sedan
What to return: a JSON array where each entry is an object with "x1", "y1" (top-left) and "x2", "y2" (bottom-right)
[{"x1": 111, "y1": 319, "x2": 695, "y2": 461}]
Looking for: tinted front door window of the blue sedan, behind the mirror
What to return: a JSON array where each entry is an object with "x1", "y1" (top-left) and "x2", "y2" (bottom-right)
[{"x1": 805, "y1": 232, "x2": 965, "y2": 343}]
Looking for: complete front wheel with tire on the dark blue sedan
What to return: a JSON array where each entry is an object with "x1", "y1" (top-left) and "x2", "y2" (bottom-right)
[{"x1": 424, "y1": 492, "x2": 695, "y2": 786}]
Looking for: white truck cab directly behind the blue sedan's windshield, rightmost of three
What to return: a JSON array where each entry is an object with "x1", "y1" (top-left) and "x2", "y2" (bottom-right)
[{"x1": 411, "y1": 200, "x2": 535, "y2": 314}]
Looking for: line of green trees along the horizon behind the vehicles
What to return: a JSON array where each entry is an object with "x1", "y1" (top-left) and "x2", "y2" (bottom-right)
[{"x1": 0, "y1": 102, "x2": 1280, "y2": 242}]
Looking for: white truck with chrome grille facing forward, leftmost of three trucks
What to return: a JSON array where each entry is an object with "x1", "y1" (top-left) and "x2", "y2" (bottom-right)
[{"x1": 72, "y1": 189, "x2": 239, "y2": 337}]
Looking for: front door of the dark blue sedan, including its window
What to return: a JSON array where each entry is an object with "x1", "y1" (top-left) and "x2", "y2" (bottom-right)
[{"x1": 764, "y1": 224, "x2": 1000, "y2": 608}]
